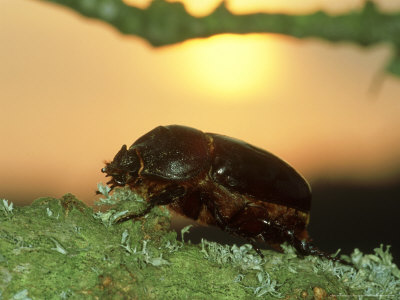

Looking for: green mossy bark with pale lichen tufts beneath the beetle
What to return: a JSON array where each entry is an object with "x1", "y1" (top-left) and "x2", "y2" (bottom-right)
[{"x1": 0, "y1": 187, "x2": 400, "y2": 299}]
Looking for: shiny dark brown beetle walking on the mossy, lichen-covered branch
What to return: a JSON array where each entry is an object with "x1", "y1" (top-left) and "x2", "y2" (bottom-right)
[{"x1": 101, "y1": 125, "x2": 341, "y2": 261}]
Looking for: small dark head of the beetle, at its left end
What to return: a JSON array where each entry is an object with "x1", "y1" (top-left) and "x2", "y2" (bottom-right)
[{"x1": 101, "y1": 145, "x2": 140, "y2": 189}]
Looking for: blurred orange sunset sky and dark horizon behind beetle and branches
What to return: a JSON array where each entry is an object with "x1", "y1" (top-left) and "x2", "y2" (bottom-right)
[{"x1": 0, "y1": 0, "x2": 400, "y2": 263}]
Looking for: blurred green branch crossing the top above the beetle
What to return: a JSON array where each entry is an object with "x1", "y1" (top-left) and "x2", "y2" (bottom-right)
[{"x1": 39, "y1": 0, "x2": 400, "y2": 76}]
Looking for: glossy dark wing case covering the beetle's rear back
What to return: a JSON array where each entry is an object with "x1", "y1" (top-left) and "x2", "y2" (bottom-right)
[{"x1": 207, "y1": 133, "x2": 311, "y2": 212}]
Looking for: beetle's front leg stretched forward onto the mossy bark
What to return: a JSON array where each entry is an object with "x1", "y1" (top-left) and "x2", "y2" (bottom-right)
[{"x1": 114, "y1": 186, "x2": 186, "y2": 223}]
